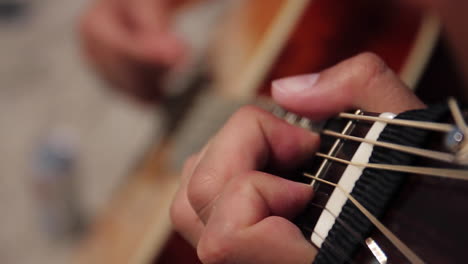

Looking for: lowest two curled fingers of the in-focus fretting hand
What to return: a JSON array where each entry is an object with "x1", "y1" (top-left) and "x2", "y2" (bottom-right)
[{"x1": 198, "y1": 171, "x2": 316, "y2": 263}]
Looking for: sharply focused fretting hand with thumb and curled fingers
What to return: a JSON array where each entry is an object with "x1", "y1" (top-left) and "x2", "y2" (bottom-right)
[{"x1": 171, "y1": 54, "x2": 424, "y2": 264}]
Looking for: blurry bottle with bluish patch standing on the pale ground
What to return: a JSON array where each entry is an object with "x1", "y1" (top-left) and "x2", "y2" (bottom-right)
[{"x1": 32, "y1": 126, "x2": 84, "y2": 240}]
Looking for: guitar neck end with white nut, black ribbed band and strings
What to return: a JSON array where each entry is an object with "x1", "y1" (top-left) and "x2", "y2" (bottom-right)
[{"x1": 290, "y1": 105, "x2": 468, "y2": 263}]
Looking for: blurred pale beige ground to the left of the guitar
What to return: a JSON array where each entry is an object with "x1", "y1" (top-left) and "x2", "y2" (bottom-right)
[{"x1": 0, "y1": 0, "x2": 164, "y2": 263}]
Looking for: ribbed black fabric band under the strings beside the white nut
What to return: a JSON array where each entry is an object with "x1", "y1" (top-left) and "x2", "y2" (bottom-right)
[{"x1": 314, "y1": 104, "x2": 448, "y2": 264}]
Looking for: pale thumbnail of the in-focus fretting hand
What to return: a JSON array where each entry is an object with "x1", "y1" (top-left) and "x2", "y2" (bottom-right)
[{"x1": 272, "y1": 73, "x2": 319, "y2": 96}]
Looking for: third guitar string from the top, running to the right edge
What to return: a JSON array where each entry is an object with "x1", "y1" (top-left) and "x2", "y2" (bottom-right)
[{"x1": 315, "y1": 152, "x2": 468, "y2": 180}]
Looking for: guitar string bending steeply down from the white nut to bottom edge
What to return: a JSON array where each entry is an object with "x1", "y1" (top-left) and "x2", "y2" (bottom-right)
[{"x1": 303, "y1": 173, "x2": 424, "y2": 264}]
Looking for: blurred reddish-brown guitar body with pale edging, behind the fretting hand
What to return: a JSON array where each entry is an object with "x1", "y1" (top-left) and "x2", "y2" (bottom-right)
[{"x1": 73, "y1": 0, "x2": 464, "y2": 263}]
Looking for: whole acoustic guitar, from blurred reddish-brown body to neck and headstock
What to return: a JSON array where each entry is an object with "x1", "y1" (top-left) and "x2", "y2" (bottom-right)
[{"x1": 76, "y1": 0, "x2": 467, "y2": 263}]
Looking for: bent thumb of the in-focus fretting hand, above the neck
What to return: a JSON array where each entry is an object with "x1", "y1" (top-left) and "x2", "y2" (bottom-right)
[{"x1": 272, "y1": 53, "x2": 424, "y2": 119}]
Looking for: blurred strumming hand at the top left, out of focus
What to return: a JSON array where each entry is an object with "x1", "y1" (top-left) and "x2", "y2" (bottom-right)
[{"x1": 80, "y1": 0, "x2": 186, "y2": 102}]
